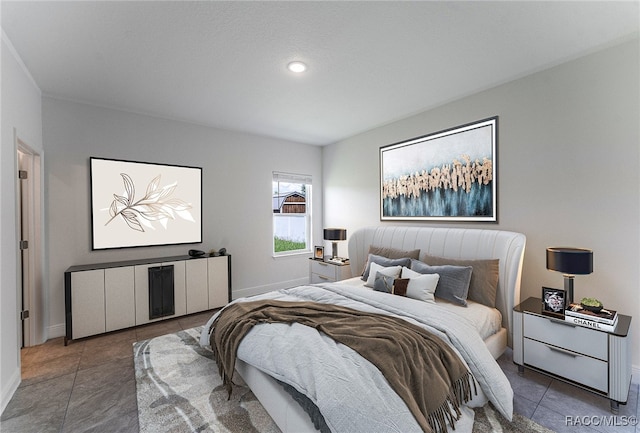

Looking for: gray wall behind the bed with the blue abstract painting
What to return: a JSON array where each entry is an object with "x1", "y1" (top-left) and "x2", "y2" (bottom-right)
[{"x1": 323, "y1": 39, "x2": 640, "y2": 372}]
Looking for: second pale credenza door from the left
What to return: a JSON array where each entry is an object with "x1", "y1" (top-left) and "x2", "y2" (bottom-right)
[{"x1": 104, "y1": 266, "x2": 136, "y2": 332}]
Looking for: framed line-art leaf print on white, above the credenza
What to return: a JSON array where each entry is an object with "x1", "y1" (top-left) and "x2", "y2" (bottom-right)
[{"x1": 89, "y1": 157, "x2": 202, "y2": 250}]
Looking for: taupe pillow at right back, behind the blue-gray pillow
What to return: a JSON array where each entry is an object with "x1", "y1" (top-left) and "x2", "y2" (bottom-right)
[{"x1": 421, "y1": 254, "x2": 500, "y2": 308}]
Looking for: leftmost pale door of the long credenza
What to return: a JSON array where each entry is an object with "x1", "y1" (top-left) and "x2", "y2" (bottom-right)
[{"x1": 71, "y1": 269, "x2": 105, "y2": 338}]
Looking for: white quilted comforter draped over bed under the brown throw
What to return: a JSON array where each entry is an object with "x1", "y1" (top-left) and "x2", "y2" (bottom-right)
[{"x1": 201, "y1": 284, "x2": 513, "y2": 433}]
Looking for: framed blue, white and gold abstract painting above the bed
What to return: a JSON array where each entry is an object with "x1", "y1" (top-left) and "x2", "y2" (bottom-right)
[{"x1": 380, "y1": 116, "x2": 498, "y2": 222}]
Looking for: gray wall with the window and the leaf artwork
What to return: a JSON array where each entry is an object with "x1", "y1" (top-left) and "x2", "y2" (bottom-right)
[{"x1": 42, "y1": 97, "x2": 322, "y2": 336}]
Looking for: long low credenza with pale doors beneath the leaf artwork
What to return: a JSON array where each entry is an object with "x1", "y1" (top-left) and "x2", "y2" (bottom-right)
[{"x1": 64, "y1": 255, "x2": 231, "y2": 345}]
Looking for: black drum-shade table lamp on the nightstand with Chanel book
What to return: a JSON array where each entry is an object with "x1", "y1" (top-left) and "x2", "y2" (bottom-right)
[{"x1": 547, "y1": 247, "x2": 593, "y2": 305}]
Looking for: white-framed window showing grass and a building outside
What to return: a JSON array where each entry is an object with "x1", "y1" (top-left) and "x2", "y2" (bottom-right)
[{"x1": 272, "y1": 172, "x2": 311, "y2": 256}]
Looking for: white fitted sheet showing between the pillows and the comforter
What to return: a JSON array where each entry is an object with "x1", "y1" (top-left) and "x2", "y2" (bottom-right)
[{"x1": 339, "y1": 277, "x2": 502, "y2": 340}]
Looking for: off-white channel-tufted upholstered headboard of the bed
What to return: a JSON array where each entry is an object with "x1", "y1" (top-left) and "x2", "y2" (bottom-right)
[{"x1": 349, "y1": 225, "x2": 526, "y2": 346}]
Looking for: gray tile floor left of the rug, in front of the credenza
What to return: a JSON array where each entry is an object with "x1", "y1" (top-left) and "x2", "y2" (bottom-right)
[{"x1": 0, "y1": 312, "x2": 213, "y2": 433}]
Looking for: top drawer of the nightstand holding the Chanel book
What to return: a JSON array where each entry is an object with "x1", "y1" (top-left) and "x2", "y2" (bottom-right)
[{"x1": 524, "y1": 314, "x2": 609, "y2": 361}]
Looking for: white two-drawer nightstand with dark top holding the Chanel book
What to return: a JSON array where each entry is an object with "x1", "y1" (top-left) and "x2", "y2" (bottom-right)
[{"x1": 513, "y1": 298, "x2": 631, "y2": 413}]
